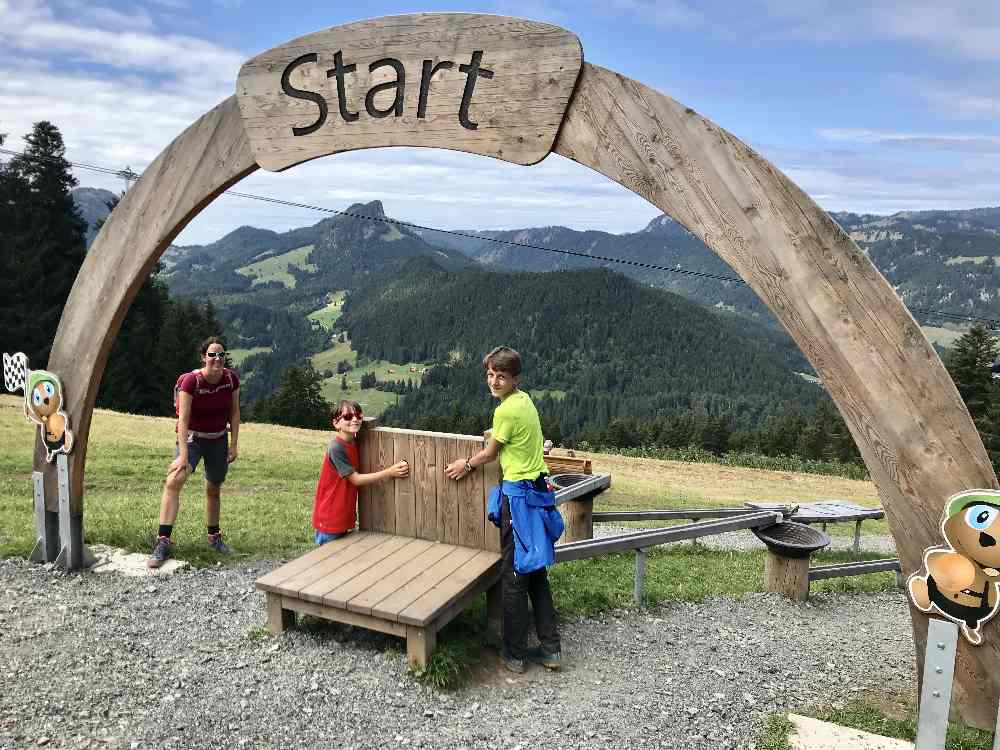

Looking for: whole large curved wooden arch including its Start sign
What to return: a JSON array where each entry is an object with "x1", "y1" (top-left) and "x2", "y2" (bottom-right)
[{"x1": 45, "y1": 14, "x2": 1000, "y2": 728}]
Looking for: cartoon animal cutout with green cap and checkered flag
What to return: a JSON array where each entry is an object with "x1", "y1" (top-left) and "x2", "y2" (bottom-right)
[{"x1": 3, "y1": 352, "x2": 73, "y2": 463}]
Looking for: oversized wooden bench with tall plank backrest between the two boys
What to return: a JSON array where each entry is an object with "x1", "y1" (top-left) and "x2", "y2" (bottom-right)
[{"x1": 256, "y1": 420, "x2": 501, "y2": 669}]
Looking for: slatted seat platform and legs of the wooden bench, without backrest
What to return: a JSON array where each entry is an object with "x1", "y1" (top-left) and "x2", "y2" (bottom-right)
[{"x1": 256, "y1": 531, "x2": 500, "y2": 668}]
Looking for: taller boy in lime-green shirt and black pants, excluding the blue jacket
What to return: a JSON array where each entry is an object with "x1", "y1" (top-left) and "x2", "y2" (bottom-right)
[{"x1": 444, "y1": 346, "x2": 562, "y2": 673}]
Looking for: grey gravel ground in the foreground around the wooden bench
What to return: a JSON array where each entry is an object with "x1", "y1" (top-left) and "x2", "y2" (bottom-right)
[{"x1": 0, "y1": 560, "x2": 916, "y2": 750}]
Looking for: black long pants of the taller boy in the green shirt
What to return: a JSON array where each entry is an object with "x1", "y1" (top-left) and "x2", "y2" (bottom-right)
[{"x1": 500, "y1": 495, "x2": 561, "y2": 659}]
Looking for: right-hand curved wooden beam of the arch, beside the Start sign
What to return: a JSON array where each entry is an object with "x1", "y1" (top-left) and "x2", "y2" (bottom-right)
[{"x1": 554, "y1": 64, "x2": 1000, "y2": 728}]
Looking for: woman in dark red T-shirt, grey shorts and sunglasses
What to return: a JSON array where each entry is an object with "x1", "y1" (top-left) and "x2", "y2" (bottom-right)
[{"x1": 148, "y1": 336, "x2": 240, "y2": 568}]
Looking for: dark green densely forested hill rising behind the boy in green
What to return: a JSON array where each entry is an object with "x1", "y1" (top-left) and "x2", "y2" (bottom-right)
[{"x1": 339, "y1": 261, "x2": 825, "y2": 439}]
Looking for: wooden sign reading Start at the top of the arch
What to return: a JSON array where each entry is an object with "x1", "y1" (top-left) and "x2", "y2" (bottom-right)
[{"x1": 236, "y1": 13, "x2": 583, "y2": 171}]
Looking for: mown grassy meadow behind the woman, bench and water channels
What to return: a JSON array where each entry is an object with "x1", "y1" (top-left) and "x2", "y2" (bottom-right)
[{"x1": 0, "y1": 396, "x2": 891, "y2": 568}]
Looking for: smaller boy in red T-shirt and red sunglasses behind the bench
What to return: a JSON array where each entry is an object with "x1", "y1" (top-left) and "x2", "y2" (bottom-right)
[{"x1": 313, "y1": 401, "x2": 410, "y2": 544}]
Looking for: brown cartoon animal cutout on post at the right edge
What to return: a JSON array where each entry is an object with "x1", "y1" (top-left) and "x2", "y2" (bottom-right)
[{"x1": 907, "y1": 490, "x2": 1000, "y2": 646}]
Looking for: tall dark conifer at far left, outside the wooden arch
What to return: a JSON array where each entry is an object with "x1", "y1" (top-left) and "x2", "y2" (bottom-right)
[{"x1": 0, "y1": 121, "x2": 86, "y2": 369}]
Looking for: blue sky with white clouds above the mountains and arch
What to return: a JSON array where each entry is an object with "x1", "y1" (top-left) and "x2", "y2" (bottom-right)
[{"x1": 0, "y1": 0, "x2": 1000, "y2": 243}]
